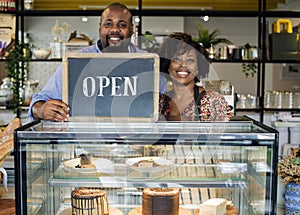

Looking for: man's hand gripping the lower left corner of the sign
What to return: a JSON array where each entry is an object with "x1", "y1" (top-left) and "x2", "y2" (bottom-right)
[{"x1": 32, "y1": 100, "x2": 70, "y2": 122}]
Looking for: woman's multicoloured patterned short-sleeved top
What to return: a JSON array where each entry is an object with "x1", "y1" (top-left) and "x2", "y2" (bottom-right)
[{"x1": 159, "y1": 90, "x2": 233, "y2": 121}]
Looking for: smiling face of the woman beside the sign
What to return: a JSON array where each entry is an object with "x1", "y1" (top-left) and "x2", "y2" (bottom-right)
[{"x1": 169, "y1": 49, "x2": 198, "y2": 85}]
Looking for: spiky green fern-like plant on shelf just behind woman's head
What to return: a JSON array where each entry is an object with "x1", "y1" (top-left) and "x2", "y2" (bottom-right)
[{"x1": 193, "y1": 22, "x2": 233, "y2": 49}]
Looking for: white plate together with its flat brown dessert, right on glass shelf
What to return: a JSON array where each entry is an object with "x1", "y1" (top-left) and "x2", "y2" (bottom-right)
[{"x1": 125, "y1": 157, "x2": 174, "y2": 172}]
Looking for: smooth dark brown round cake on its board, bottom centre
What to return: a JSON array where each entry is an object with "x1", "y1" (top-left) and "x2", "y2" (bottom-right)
[{"x1": 128, "y1": 188, "x2": 192, "y2": 215}]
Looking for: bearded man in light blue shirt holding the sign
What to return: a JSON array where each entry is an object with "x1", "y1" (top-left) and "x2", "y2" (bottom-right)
[{"x1": 29, "y1": 3, "x2": 166, "y2": 122}]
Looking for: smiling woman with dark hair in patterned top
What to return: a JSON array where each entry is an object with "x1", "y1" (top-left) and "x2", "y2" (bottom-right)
[{"x1": 158, "y1": 32, "x2": 233, "y2": 121}]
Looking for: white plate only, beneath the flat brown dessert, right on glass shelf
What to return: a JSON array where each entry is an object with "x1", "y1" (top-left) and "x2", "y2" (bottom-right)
[{"x1": 125, "y1": 157, "x2": 174, "y2": 172}]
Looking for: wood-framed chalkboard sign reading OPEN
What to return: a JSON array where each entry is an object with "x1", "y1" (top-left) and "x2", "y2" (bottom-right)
[{"x1": 62, "y1": 53, "x2": 159, "y2": 122}]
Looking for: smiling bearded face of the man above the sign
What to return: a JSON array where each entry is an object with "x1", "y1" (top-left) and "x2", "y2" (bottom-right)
[{"x1": 99, "y1": 8, "x2": 133, "y2": 48}]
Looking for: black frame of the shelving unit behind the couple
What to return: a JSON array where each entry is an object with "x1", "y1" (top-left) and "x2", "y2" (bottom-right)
[{"x1": 1, "y1": 0, "x2": 300, "y2": 122}]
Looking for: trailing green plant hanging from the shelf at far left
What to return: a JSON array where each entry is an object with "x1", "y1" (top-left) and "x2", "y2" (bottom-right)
[{"x1": 5, "y1": 42, "x2": 32, "y2": 117}]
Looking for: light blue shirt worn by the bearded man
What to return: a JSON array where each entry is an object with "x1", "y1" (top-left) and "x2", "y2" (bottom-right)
[{"x1": 28, "y1": 41, "x2": 167, "y2": 120}]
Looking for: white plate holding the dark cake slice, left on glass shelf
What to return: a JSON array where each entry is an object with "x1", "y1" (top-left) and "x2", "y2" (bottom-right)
[{"x1": 64, "y1": 158, "x2": 113, "y2": 173}]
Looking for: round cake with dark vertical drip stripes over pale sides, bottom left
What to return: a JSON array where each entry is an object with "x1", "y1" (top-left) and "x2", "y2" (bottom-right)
[{"x1": 71, "y1": 187, "x2": 109, "y2": 215}]
